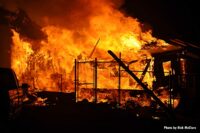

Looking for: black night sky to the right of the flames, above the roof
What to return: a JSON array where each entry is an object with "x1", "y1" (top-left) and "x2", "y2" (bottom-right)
[{"x1": 122, "y1": 0, "x2": 200, "y2": 45}]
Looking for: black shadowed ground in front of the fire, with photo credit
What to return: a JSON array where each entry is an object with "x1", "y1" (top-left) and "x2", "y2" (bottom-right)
[{"x1": 0, "y1": 92, "x2": 200, "y2": 133}]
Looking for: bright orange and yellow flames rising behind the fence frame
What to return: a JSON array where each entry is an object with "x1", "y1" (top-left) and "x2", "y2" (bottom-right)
[{"x1": 12, "y1": 1, "x2": 178, "y2": 108}]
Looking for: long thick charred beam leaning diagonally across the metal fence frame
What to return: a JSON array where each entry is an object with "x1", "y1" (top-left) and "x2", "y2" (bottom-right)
[{"x1": 108, "y1": 50, "x2": 174, "y2": 118}]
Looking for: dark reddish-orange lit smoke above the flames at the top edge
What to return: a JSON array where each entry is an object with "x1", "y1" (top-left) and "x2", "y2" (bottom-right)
[{"x1": 0, "y1": 0, "x2": 123, "y2": 30}]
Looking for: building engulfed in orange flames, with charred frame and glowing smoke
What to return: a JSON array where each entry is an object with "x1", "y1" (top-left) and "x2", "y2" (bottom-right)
[{"x1": 1, "y1": 0, "x2": 199, "y2": 125}]
